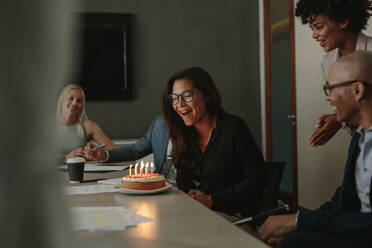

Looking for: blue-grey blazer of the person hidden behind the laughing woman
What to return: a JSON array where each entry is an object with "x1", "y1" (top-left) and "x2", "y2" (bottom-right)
[{"x1": 107, "y1": 116, "x2": 169, "y2": 173}]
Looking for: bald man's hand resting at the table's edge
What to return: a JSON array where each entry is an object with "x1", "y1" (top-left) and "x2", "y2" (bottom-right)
[{"x1": 258, "y1": 214, "x2": 297, "y2": 245}]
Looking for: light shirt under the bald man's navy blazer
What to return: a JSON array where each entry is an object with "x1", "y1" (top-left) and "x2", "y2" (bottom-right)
[{"x1": 355, "y1": 127, "x2": 372, "y2": 213}]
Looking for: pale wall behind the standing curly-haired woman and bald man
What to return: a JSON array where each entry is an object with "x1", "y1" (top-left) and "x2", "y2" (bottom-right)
[{"x1": 294, "y1": 0, "x2": 372, "y2": 208}]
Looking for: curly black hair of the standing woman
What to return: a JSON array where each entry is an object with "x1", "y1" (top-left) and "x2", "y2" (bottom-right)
[{"x1": 295, "y1": 0, "x2": 372, "y2": 33}]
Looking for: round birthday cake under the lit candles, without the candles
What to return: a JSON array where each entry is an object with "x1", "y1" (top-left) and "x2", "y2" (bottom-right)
[{"x1": 121, "y1": 173, "x2": 165, "y2": 190}]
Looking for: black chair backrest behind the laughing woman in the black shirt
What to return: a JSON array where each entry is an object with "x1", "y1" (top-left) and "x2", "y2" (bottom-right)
[{"x1": 260, "y1": 162, "x2": 285, "y2": 211}]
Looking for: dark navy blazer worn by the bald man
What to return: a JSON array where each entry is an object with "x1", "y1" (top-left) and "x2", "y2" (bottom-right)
[{"x1": 297, "y1": 132, "x2": 372, "y2": 244}]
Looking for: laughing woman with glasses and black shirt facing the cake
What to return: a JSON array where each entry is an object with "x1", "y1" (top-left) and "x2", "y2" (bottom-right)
[{"x1": 163, "y1": 67, "x2": 266, "y2": 223}]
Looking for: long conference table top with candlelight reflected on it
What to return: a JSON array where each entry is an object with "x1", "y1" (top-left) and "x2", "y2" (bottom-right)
[{"x1": 61, "y1": 163, "x2": 268, "y2": 248}]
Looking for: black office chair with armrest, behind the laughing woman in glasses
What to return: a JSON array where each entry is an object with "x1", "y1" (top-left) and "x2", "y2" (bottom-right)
[{"x1": 233, "y1": 162, "x2": 289, "y2": 227}]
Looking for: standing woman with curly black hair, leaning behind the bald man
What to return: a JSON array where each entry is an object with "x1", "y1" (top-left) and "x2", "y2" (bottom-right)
[{"x1": 295, "y1": 0, "x2": 372, "y2": 146}]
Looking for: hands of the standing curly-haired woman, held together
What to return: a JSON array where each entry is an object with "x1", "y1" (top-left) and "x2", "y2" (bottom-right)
[{"x1": 309, "y1": 114, "x2": 341, "y2": 146}]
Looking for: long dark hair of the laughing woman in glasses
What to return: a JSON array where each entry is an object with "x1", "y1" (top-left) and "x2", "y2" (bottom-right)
[{"x1": 162, "y1": 67, "x2": 221, "y2": 170}]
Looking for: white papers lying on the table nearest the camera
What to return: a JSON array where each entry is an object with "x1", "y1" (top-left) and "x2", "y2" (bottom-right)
[{"x1": 71, "y1": 206, "x2": 153, "y2": 231}]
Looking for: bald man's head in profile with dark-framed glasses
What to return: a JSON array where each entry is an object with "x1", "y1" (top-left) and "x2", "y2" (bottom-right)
[{"x1": 327, "y1": 51, "x2": 372, "y2": 129}]
